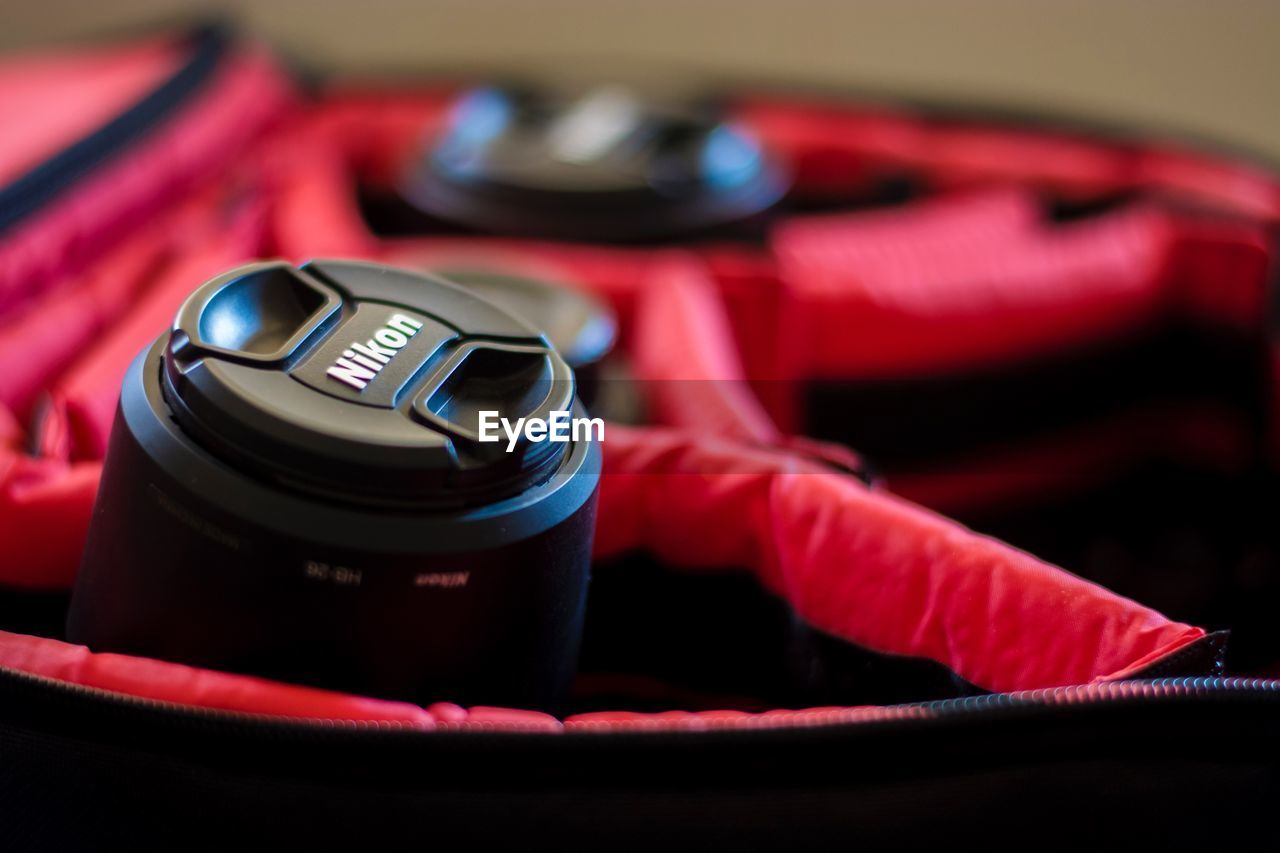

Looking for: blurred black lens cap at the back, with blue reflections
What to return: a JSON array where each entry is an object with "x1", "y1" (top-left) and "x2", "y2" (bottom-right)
[{"x1": 404, "y1": 85, "x2": 786, "y2": 242}]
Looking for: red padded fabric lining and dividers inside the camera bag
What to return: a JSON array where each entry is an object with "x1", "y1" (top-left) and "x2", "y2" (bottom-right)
[{"x1": 0, "y1": 36, "x2": 1264, "y2": 731}]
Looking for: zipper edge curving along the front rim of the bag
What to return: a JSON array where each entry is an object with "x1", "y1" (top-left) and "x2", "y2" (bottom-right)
[{"x1": 0, "y1": 666, "x2": 1280, "y2": 734}]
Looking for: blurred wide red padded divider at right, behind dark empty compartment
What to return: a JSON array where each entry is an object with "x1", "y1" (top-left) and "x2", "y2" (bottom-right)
[{"x1": 774, "y1": 195, "x2": 1170, "y2": 379}]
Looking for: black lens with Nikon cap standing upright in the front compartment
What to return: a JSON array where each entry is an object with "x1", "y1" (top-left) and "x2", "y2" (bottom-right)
[{"x1": 68, "y1": 261, "x2": 603, "y2": 708}]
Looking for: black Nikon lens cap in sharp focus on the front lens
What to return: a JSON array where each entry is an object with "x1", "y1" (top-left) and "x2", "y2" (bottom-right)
[{"x1": 161, "y1": 260, "x2": 575, "y2": 506}]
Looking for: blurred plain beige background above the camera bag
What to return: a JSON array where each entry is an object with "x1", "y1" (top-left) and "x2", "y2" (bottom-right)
[{"x1": 0, "y1": 0, "x2": 1280, "y2": 156}]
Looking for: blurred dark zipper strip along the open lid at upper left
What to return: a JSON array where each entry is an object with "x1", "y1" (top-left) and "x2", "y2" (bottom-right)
[{"x1": 0, "y1": 24, "x2": 232, "y2": 234}]
